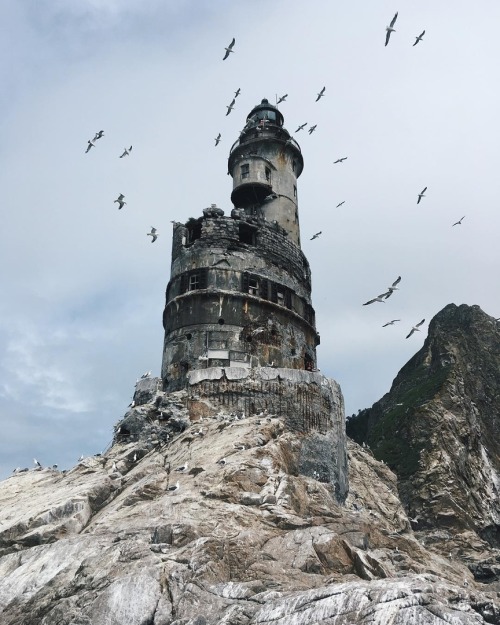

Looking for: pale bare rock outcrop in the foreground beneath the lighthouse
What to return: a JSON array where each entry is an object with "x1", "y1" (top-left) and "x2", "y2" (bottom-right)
[{"x1": 0, "y1": 392, "x2": 499, "y2": 625}]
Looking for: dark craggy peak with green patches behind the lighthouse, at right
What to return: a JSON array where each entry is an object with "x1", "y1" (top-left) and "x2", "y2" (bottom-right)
[{"x1": 347, "y1": 304, "x2": 500, "y2": 582}]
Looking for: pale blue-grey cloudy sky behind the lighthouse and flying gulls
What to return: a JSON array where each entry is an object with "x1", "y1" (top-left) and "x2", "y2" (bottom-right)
[{"x1": 0, "y1": 0, "x2": 500, "y2": 477}]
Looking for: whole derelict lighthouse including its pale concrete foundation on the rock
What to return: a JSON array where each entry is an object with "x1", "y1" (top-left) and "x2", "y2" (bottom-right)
[{"x1": 161, "y1": 100, "x2": 347, "y2": 499}]
